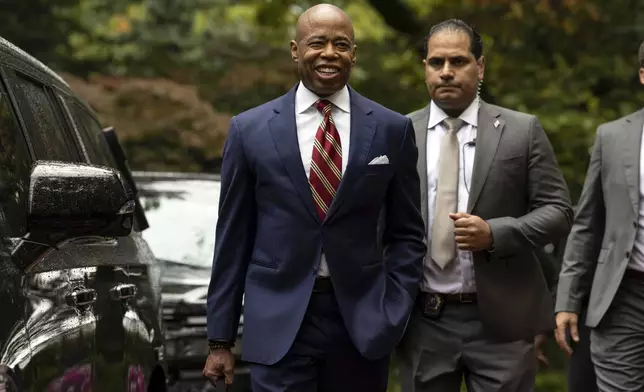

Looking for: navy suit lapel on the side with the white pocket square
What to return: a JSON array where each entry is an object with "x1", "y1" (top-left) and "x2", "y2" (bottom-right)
[{"x1": 325, "y1": 86, "x2": 377, "y2": 221}]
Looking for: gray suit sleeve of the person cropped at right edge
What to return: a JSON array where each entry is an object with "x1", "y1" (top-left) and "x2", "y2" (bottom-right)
[{"x1": 555, "y1": 128, "x2": 606, "y2": 314}]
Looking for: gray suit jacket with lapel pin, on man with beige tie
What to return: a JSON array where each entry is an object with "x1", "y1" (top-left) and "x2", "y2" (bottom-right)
[{"x1": 409, "y1": 102, "x2": 573, "y2": 341}]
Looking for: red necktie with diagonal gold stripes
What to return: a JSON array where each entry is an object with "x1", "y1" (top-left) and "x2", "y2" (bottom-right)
[{"x1": 309, "y1": 99, "x2": 342, "y2": 220}]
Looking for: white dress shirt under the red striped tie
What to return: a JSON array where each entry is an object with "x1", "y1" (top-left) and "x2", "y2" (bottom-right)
[{"x1": 295, "y1": 82, "x2": 351, "y2": 276}]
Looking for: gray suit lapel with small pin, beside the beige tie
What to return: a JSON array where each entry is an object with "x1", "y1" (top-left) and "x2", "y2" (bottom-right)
[{"x1": 467, "y1": 101, "x2": 505, "y2": 213}]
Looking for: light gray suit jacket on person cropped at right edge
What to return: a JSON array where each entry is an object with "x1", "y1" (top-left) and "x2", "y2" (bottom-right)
[{"x1": 555, "y1": 110, "x2": 644, "y2": 327}]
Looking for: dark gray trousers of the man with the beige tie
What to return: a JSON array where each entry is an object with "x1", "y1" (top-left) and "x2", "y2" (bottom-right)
[{"x1": 396, "y1": 303, "x2": 537, "y2": 392}]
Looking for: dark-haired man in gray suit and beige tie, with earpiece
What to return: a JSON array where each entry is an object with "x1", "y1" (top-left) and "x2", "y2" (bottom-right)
[{"x1": 397, "y1": 20, "x2": 573, "y2": 392}]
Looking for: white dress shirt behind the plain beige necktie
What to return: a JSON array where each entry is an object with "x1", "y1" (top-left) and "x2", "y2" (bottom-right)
[{"x1": 421, "y1": 98, "x2": 479, "y2": 294}]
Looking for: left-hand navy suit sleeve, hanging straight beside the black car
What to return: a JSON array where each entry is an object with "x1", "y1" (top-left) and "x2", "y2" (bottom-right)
[{"x1": 207, "y1": 117, "x2": 256, "y2": 341}]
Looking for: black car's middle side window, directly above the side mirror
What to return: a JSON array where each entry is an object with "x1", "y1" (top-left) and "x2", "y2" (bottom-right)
[{"x1": 12, "y1": 72, "x2": 81, "y2": 162}]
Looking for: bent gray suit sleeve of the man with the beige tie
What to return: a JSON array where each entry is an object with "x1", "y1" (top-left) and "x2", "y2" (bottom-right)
[{"x1": 487, "y1": 117, "x2": 573, "y2": 257}]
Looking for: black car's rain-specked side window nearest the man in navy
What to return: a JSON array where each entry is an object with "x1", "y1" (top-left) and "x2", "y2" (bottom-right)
[{"x1": 65, "y1": 98, "x2": 115, "y2": 167}]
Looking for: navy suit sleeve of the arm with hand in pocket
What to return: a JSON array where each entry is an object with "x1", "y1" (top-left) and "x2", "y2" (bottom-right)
[{"x1": 382, "y1": 119, "x2": 427, "y2": 303}]
